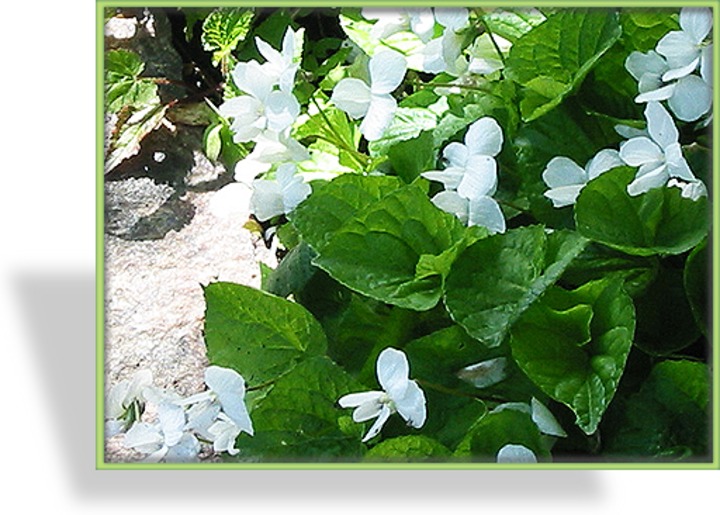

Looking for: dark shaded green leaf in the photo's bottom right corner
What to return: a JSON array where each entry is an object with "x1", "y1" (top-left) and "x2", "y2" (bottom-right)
[{"x1": 606, "y1": 360, "x2": 711, "y2": 461}]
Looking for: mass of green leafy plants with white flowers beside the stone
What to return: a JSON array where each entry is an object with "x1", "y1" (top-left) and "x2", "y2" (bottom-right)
[{"x1": 104, "y1": 7, "x2": 713, "y2": 464}]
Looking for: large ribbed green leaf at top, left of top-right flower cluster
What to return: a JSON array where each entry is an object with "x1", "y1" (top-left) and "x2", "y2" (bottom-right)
[{"x1": 505, "y1": 9, "x2": 622, "y2": 121}]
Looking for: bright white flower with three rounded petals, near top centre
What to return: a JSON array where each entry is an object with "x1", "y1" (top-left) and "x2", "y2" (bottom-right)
[{"x1": 330, "y1": 50, "x2": 407, "y2": 141}]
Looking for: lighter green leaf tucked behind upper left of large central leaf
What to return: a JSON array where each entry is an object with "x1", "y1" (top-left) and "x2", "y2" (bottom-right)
[{"x1": 291, "y1": 174, "x2": 402, "y2": 251}]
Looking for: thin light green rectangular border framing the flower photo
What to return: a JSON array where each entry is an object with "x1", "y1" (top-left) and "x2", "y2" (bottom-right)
[{"x1": 95, "y1": 0, "x2": 720, "y2": 470}]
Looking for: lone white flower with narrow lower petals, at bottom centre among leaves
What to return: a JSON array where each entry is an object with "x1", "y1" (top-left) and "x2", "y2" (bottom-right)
[{"x1": 338, "y1": 348, "x2": 427, "y2": 442}]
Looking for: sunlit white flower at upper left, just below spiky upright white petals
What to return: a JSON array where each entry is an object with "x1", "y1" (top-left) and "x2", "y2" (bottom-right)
[{"x1": 219, "y1": 61, "x2": 300, "y2": 142}]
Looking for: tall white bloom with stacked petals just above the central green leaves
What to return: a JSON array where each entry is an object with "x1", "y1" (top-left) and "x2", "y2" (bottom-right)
[{"x1": 421, "y1": 117, "x2": 506, "y2": 233}]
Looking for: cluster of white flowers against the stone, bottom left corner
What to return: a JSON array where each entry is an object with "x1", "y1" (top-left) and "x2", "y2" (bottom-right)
[{"x1": 106, "y1": 366, "x2": 253, "y2": 462}]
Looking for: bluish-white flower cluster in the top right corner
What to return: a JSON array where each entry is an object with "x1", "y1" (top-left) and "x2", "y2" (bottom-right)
[{"x1": 625, "y1": 7, "x2": 712, "y2": 122}]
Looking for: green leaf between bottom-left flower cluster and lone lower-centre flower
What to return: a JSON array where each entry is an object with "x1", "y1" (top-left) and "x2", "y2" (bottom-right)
[{"x1": 238, "y1": 356, "x2": 364, "y2": 461}]
